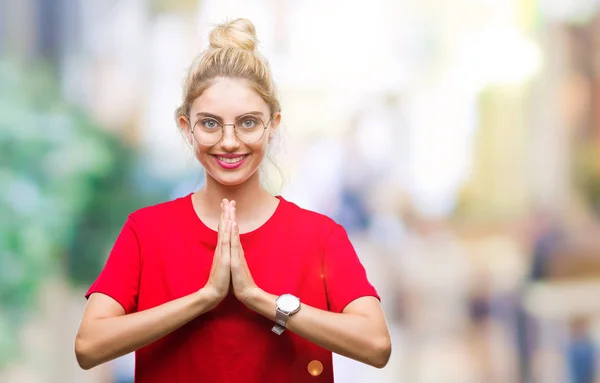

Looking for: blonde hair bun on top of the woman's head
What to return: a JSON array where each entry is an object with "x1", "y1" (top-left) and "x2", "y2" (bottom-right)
[{"x1": 209, "y1": 18, "x2": 257, "y2": 52}]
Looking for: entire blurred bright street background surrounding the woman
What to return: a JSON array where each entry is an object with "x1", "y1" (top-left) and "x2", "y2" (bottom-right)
[{"x1": 0, "y1": 0, "x2": 600, "y2": 383}]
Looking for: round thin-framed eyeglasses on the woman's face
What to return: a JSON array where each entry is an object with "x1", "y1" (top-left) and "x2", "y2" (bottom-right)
[{"x1": 188, "y1": 114, "x2": 273, "y2": 146}]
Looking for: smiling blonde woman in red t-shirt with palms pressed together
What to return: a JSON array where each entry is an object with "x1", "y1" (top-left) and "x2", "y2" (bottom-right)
[{"x1": 75, "y1": 19, "x2": 391, "y2": 383}]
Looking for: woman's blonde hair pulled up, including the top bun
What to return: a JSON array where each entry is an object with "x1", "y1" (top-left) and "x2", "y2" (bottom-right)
[{"x1": 175, "y1": 18, "x2": 281, "y2": 124}]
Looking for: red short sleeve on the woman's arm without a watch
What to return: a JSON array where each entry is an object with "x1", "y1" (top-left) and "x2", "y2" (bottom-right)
[{"x1": 85, "y1": 217, "x2": 141, "y2": 314}]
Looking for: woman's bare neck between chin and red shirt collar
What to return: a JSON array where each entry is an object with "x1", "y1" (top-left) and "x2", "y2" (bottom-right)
[{"x1": 196, "y1": 172, "x2": 273, "y2": 221}]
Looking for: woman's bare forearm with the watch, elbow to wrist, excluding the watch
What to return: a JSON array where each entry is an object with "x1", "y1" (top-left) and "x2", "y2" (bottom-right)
[{"x1": 248, "y1": 290, "x2": 390, "y2": 368}]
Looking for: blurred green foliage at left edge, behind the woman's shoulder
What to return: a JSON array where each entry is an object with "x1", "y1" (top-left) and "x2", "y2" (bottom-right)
[{"x1": 0, "y1": 61, "x2": 164, "y2": 366}]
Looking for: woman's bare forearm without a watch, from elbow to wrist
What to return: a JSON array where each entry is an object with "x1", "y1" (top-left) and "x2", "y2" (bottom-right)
[{"x1": 75, "y1": 290, "x2": 214, "y2": 369}]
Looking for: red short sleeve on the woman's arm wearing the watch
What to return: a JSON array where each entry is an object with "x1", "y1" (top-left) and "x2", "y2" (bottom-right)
[{"x1": 323, "y1": 225, "x2": 380, "y2": 313}]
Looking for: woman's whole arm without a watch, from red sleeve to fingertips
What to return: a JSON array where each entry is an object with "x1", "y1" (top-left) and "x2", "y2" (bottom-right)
[{"x1": 75, "y1": 204, "x2": 231, "y2": 370}]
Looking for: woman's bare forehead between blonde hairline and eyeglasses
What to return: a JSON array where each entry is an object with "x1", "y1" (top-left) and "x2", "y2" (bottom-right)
[{"x1": 190, "y1": 78, "x2": 268, "y2": 117}]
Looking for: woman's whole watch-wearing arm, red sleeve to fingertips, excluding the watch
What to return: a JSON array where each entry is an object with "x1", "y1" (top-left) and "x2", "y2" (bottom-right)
[{"x1": 231, "y1": 204, "x2": 392, "y2": 368}]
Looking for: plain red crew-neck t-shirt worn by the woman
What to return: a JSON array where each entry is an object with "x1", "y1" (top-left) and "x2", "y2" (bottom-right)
[{"x1": 86, "y1": 194, "x2": 379, "y2": 383}]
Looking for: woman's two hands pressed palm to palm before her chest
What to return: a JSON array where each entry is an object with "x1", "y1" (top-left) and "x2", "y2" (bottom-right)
[{"x1": 204, "y1": 199, "x2": 258, "y2": 305}]
